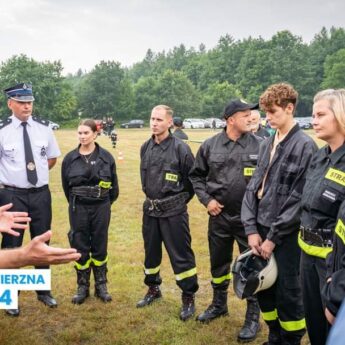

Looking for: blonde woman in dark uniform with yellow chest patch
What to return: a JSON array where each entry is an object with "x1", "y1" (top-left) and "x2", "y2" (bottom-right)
[{"x1": 299, "y1": 89, "x2": 345, "y2": 345}]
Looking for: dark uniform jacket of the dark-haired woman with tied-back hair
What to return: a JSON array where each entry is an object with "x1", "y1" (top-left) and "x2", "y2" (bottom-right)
[{"x1": 61, "y1": 143, "x2": 119, "y2": 203}]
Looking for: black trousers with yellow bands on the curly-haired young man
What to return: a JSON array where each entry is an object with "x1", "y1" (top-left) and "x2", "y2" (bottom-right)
[{"x1": 257, "y1": 226, "x2": 306, "y2": 344}]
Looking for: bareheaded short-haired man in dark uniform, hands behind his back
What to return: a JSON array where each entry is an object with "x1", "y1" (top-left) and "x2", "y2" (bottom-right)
[{"x1": 137, "y1": 105, "x2": 198, "y2": 321}]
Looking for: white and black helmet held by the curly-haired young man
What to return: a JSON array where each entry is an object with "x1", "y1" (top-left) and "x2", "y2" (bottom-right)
[{"x1": 232, "y1": 250, "x2": 278, "y2": 299}]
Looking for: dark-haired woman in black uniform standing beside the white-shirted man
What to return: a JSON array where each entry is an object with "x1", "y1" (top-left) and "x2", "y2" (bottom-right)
[{"x1": 61, "y1": 120, "x2": 119, "y2": 304}]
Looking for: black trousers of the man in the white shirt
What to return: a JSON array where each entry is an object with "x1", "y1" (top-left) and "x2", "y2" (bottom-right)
[{"x1": 0, "y1": 186, "x2": 52, "y2": 268}]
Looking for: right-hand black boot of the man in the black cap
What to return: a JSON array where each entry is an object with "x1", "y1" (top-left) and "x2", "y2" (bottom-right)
[{"x1": 237, "y1": 297, "x2": 260, "y2": 343}]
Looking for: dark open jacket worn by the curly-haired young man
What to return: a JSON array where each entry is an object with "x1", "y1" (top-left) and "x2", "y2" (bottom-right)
[{"x1": 241, "y1": 124, "x2": 317, "y2": 244}]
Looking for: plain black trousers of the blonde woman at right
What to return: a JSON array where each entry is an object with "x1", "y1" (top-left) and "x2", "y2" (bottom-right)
[{"x1": 301, "y1": 251, "x2": 330, "y2": 345}]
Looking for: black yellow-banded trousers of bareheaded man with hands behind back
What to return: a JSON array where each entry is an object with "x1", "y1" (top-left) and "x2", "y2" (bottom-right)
[{"x1": 142, "y1": 212, "x2": 199, "y2": 295}]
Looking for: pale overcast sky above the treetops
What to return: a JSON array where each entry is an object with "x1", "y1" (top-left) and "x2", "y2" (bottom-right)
[{"x1": 0, "y1": 0, "x2": 345, "y2": 74}]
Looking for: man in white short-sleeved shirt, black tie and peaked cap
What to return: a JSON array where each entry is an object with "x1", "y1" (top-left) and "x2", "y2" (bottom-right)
[{"x1": 0, "y1": 83, "x2": 60, "y2": 316}]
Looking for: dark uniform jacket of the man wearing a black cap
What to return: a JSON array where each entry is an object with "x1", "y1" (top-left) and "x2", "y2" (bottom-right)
[{"x1": 189, "y1": 128, "x2": 262, "y2": 223}]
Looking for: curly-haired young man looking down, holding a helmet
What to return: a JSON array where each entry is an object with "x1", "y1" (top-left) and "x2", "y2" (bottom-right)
[{"x1": 241, "y1": 83, "x2": 317, "y2": 345}]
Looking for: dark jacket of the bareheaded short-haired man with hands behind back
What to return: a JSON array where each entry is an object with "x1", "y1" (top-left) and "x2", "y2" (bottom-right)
[{"x1": 140, "y1": 134, "x2": 194, "y2": 217}]
